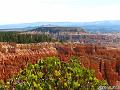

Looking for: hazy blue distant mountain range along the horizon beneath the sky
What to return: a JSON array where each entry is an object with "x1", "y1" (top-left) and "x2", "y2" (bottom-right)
[{"x1": 0, "y1": 20, "x2": 120, "y2": 33}]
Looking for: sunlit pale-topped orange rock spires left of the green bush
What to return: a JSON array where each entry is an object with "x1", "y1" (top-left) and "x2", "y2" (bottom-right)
[{"x1": 0, "y1": 45, "x2": 57, "y2": 80}]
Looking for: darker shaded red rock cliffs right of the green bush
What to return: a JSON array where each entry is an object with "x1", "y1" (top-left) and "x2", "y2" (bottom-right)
[{"x1": 58, "y1": 45, "x2": 120, "y2": 85}]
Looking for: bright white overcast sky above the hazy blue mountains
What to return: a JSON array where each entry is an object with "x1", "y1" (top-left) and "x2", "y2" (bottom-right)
[{"x1": 0, "y1": 0, "x2": 120, "y2": 25}]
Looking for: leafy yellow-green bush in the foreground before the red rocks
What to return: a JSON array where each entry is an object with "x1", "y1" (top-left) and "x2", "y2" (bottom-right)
[{"x1": 0, "y1": 57, "x2": 107, "y2": 90}]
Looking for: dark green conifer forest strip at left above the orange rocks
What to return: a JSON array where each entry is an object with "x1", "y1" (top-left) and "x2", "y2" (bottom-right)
[{"x1": 0, "y1": 32, "x2": 52, "y2": 43}]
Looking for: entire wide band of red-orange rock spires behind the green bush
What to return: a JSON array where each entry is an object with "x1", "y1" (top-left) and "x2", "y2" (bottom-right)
[{"x1": 0, "y1": 42, "x2": 120, "y2": 85}]
